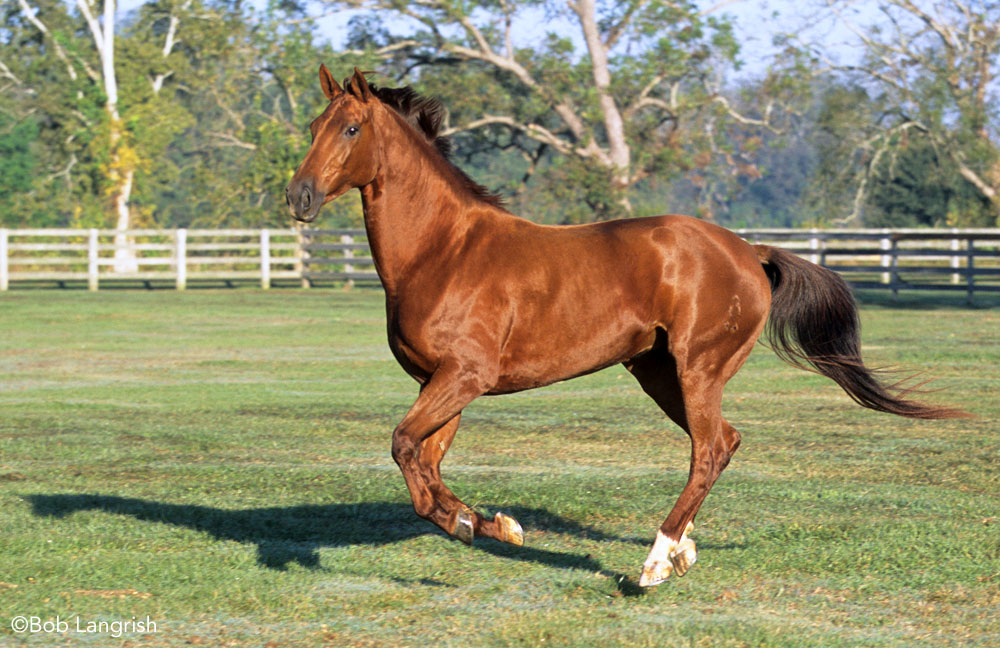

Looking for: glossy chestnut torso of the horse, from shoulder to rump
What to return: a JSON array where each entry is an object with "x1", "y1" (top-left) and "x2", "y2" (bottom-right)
[{"x1": 390, "y1": 216, "x2": 767, "y2": 393}]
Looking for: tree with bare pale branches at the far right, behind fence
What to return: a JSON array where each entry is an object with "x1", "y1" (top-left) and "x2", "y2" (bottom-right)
[{"x1": 793, "y1": 0, "x2": 1000, "y2": 224}]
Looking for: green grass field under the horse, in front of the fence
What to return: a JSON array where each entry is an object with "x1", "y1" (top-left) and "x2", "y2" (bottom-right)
[{"x1": 0, "y1": 290, "x2": 1000, "y2": 647}]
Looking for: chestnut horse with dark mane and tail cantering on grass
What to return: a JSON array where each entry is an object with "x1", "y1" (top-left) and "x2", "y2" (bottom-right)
[{"x1": 286, "y1": 66, "x2": 962, "y2": 586}]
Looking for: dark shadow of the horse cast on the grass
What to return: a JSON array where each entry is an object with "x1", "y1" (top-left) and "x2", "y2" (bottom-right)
[{"x1": 24, "y1": 494, "x2": 648, "y2": 587}]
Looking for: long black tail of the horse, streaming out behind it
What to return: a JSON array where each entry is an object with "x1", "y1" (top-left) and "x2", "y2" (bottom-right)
[{"x1": 754, "y1": 245, "x2": 969, "y2": 419}]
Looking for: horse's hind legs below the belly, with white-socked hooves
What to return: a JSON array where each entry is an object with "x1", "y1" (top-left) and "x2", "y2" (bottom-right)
[{"x1": 625, "y1": 349, "x2": 740, "y2": 587}]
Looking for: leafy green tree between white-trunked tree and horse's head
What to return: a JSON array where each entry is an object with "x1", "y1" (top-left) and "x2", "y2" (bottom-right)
[{"x1": 150, "y1": 1, "x2": 372, "y2": 227}]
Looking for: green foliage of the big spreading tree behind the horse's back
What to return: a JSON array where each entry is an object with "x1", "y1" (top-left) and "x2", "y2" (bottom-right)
[{"x1": 334, "y1": 1, "x2": 752, "y2": 222}]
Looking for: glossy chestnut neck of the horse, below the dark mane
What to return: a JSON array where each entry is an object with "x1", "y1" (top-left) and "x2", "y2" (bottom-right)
[{"x1": 360, "y1": 108, "x2": 489, "y2": 294}]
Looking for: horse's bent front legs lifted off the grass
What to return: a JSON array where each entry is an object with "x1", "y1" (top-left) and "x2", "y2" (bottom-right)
[{"x1": 392, "y1": 370, "x2": 524, "y2": 545}]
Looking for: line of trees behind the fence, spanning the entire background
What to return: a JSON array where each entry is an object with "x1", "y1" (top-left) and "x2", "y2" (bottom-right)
[{"x1": 0, "y1": 0, "x2": 1000, "y2": 233}]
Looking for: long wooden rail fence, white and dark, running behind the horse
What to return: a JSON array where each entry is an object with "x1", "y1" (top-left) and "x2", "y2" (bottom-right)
[{"x1": 0, "y1": 229, "x2": 1000, "y2": 300}]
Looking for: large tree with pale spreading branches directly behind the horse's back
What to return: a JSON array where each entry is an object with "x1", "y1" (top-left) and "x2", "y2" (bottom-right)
[{"x1": 327, "y1": 0, "x2": 770, "y2": 217}]
